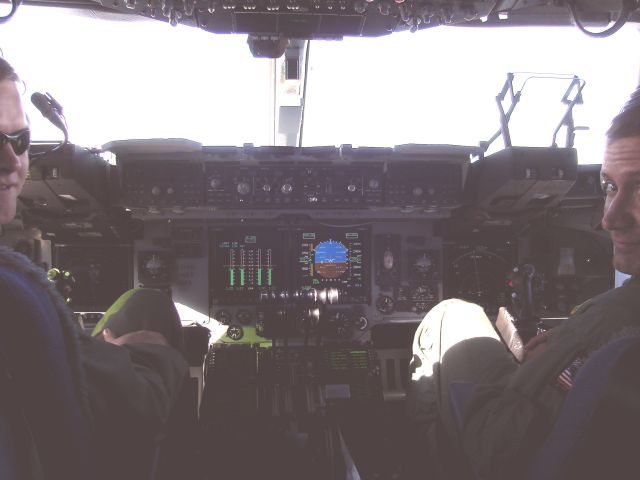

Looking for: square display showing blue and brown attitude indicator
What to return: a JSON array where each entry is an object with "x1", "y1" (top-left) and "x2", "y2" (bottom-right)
[{"x1": 296, "y1": 227, "x2": 370, "y2": 303}]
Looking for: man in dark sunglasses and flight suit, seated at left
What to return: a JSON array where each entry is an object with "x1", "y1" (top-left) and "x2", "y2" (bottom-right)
[{"x1": 0, "y1": 58, "x2": 188, "y2": 479}]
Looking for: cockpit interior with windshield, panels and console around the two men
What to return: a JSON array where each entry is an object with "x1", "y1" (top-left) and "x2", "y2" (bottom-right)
[{"x1": 0, "y1": 0, "x2": 640, "y2": 480}]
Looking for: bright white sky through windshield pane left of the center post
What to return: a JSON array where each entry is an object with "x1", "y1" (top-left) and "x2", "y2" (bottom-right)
[{"x1": 0, "y1": 6, "x2": 273, "y2": 146}]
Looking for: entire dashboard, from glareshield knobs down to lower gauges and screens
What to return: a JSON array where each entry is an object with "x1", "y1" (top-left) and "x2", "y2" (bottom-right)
[{"x1": 15, "y1": 142, "x2": 611, "y2": 344}]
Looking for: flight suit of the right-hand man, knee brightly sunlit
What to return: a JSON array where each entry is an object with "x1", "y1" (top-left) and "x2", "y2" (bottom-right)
[{"x1": 409, "y1": 278, "x2": 640, "y2": 479}]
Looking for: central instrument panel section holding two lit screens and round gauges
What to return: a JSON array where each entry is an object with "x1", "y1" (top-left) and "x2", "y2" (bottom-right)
[{"x1": 202, "y1": 219, "x2": 442, "y2": 342}]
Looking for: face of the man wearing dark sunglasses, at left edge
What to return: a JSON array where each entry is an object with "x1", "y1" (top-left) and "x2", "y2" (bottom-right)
[{"x1": 0, "y1": 80, "x2": 29, "y2": 225}]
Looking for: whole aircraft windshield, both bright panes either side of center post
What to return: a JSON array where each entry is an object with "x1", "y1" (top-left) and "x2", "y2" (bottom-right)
[{"x1": 0, "y1": 6, "x2": 640, "y2": 163}]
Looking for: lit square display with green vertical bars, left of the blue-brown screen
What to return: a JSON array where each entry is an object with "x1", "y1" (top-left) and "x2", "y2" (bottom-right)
[{"x1": 209, "y1": 228, "x2": 286, "y2": 304}]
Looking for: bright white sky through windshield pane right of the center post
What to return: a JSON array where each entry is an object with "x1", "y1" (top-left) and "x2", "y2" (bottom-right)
[{"x1": 304, "y1": 26, "x2": 640, "y2": 163}]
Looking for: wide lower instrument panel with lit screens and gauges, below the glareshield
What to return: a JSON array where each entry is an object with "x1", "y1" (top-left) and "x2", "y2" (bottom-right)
[{"x1": 47, "y1": 217, "x2": 612, "y2": 344}]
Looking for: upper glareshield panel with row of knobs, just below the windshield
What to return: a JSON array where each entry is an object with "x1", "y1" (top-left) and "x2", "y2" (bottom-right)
[{"x1": 117, "y1": 145, "x2": 475, "y2": 214}]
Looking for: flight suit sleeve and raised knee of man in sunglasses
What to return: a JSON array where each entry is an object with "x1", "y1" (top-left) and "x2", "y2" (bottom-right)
[{"x1": 80, "y1": 289, "x2": 188, "y2": 480}]
